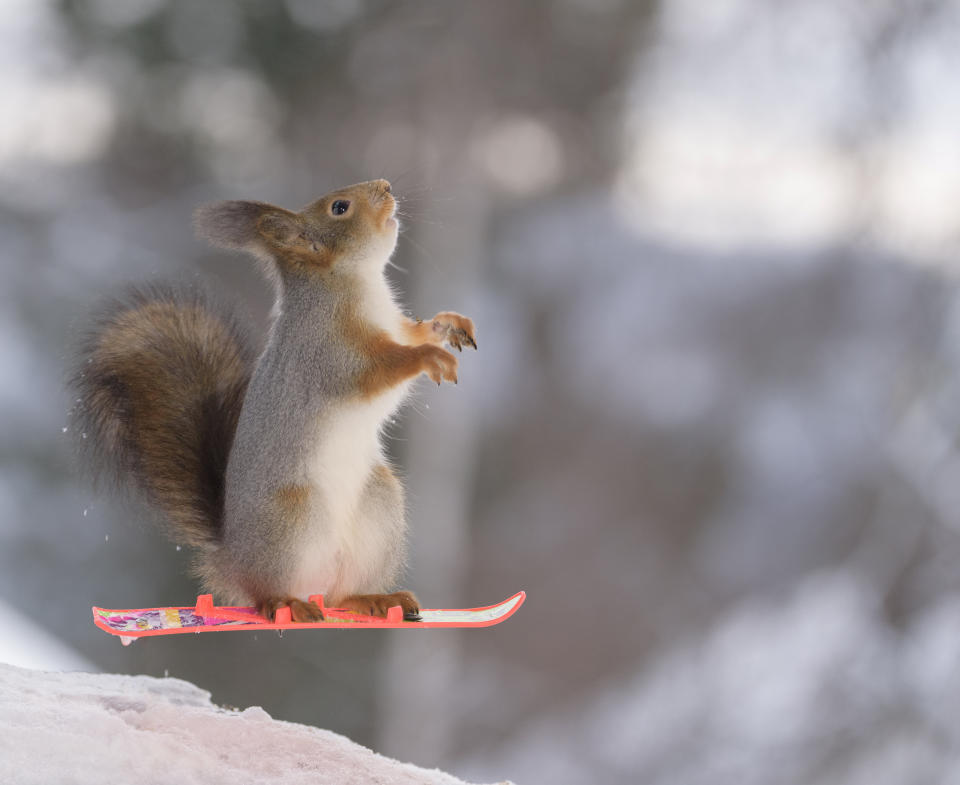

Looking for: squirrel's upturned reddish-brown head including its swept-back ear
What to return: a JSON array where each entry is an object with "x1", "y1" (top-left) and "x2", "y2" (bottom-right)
[{"x1": 194, "y1": 180, "x2": 399, "y2": 284}]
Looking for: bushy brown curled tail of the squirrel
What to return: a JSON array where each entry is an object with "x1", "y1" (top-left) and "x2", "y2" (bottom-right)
[{"x1": 69, "y1": 284, "x2": 254, "y2": 547}]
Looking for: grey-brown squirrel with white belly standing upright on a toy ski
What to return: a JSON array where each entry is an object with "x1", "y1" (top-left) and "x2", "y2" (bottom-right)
[{"x1": 70, "y1": 180, "x2": 477, "y2": 622}]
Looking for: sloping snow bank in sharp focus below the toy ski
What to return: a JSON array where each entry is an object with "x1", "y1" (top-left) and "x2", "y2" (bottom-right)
[{"x1": 0, "y1": 665, "x2": 510, "y2": 785}]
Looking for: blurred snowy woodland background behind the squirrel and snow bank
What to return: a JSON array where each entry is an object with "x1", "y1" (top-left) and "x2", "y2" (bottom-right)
[{"x1": 0, "y1": 0, "x2": 960, "y2": 785}]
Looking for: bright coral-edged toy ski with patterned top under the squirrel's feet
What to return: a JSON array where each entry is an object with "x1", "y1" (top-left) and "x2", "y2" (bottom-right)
[{"x1": 93, "y1": 591, "x2": 527, "y2": 646}]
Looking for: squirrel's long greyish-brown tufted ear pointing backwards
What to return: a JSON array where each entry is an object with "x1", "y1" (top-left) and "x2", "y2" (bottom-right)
[{"x1": 193, "y1": 201, "x2": 300, "y2": 251}]
